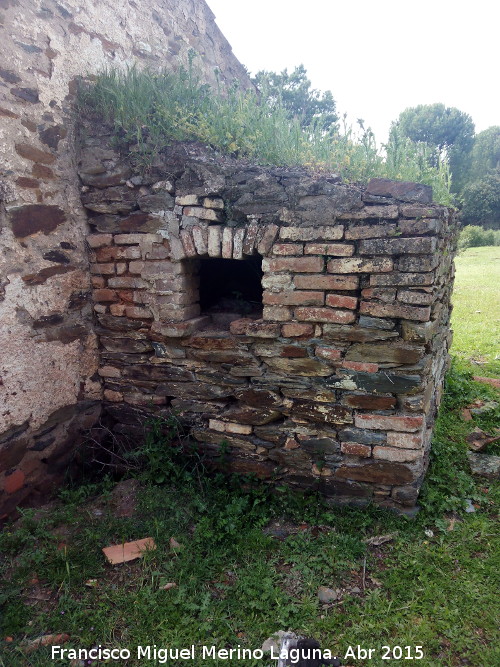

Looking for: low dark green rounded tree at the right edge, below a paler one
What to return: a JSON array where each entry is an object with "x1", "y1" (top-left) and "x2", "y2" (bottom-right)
[{"x1": 460, "y1": 168, "x2": 500, "y2": 229}]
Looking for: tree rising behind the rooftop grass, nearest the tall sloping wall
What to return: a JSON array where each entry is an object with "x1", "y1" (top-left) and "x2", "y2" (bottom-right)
[{"x1": 252, "y1": 65, "x2": 338, "y2": 131}]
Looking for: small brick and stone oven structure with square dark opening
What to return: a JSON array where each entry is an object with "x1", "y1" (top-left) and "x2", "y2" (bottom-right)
[{"x1": 79, "y1": 135, "x2": 455, "y2": 508}]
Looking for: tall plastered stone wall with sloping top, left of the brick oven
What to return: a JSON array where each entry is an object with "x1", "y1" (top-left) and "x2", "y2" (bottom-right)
[{"x1": 0, "y1": 0, "x2": 250, "y2": 517}]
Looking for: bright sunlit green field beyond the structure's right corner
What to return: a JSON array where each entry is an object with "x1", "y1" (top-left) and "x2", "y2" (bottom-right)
[{"x1": 452, "y1": 246, "x2": 500, "y2": 376}]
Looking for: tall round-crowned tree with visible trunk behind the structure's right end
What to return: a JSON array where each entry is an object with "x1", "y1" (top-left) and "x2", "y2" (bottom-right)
[{"x1": 391, "y1": 104, "x2": 474, "y2": 192}]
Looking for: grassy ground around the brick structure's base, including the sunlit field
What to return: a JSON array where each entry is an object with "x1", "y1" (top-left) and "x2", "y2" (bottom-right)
[{"x1": 0, "y1": 248, "x2": 500, "y2": 667}]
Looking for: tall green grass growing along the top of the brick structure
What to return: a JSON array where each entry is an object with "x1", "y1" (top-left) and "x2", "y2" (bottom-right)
[{"x1": 79, "y1": 60, "x2": 452, "y2": 204}]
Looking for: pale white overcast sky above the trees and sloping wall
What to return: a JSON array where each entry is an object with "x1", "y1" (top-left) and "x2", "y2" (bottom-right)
[{"x1": 207, "y1": 0, "x2": 500, "y2": 143}]
